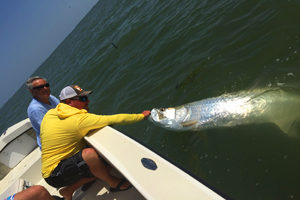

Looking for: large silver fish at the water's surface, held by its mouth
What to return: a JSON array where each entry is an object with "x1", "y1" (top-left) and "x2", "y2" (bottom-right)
[{"x1": 149, "y1": 88, "x2": 300, "y2": 132}]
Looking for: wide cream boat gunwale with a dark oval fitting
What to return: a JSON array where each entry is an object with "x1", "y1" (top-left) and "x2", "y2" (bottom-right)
[{"x1": 85, "y1": 126, "x2": 223, "y2": 200}]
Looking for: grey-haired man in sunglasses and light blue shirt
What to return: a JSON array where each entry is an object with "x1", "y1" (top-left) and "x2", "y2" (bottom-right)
[{"x1": 26, "y1": 76, "x2": 59, "y2": 148}]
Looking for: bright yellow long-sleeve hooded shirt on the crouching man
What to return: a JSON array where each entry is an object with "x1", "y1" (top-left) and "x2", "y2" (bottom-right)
[{"x1": 40, "y1": 103, "x2": 144, "y2": 178}]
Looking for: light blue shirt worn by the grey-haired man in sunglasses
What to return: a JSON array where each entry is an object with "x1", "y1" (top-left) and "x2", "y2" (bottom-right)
[{"x1": 27, "y1": 95, "x2": 59, "y2": 148}]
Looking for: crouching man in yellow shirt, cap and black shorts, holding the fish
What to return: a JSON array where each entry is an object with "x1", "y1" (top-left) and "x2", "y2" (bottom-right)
[{"x1": 41, "y1": 85, "x2": 150, "y2": 200}]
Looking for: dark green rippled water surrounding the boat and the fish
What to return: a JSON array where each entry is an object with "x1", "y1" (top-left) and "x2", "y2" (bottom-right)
[{"x1": 0, "y1": 0, "x2": 300, "y2": 200}]
